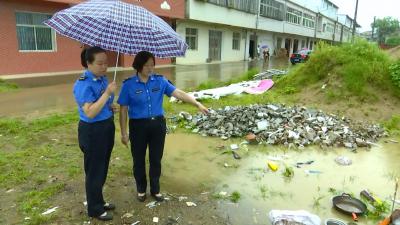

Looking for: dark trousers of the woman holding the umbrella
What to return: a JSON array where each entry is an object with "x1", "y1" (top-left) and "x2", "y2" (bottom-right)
[{"x1": 78, "y1": 117, "x2": 115, "y2": 217}]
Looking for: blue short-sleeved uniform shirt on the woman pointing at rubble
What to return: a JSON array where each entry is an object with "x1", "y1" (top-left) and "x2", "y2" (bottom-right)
[{"x1": 118, "y1": 74, "x2": 176, "y2": 119}]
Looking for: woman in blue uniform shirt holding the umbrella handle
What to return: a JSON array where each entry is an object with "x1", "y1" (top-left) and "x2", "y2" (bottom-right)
[{"x1": 74, "y1": 47, "x2": 117, "y2": 220}]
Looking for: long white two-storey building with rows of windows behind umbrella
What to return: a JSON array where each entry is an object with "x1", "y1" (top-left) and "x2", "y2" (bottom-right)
[{"x1": 176, "y1": 0, "x2": 358, "y2": 64}]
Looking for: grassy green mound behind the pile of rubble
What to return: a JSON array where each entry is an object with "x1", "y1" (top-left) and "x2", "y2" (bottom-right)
[{"x1": 278, "y1": 40, "x2": 400, "y2": 103}]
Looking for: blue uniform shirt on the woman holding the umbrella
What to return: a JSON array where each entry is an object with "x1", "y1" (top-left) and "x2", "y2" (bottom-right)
[{"x1": 74, "y1": 70, "x2": 114, "y2": 123}]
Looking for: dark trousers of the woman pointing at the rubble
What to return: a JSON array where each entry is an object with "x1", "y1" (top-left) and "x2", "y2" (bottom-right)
[{"x1": 129, "y1": 116, "x2": 167, "y2": 194}]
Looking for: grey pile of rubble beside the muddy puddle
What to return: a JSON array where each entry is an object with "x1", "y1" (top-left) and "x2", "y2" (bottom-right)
[{"x1": 180, "y1": 104, "x2": 387, "y2": 149}]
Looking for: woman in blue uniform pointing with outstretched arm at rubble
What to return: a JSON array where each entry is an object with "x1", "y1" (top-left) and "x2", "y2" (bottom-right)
[{"x1": 118, "y1": 51, "x2": 208, "y2": 202}]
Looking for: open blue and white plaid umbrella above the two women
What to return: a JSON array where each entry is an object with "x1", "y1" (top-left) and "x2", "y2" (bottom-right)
[{"x1": 44, "y1": 0, "x2": 188, "y2": 80}]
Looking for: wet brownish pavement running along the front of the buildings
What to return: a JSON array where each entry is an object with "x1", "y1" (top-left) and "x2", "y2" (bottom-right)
[{"x1": 0, "y1": 60, "x2": 289, "y2": 116}]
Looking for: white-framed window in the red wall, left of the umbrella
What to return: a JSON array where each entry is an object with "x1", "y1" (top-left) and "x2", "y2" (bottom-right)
[{"x1": 15, "y1": 12, "x2": 56, "y2": 51}]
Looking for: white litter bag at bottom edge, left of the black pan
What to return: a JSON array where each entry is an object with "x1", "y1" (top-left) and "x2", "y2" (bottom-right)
[{"x1": 269, "y1": 210, "x2": 321, "y2": 225}]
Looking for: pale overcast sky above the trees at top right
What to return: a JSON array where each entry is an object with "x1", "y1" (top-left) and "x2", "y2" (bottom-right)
[{"x1": 331, "y1": 0, "x2": 400, "y2": 31}]
